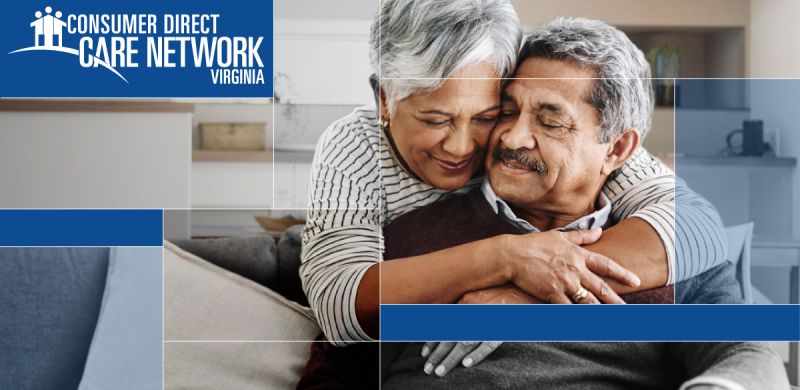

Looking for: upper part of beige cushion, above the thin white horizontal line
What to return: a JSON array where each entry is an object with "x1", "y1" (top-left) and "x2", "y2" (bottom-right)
[{"x1": 164, "y1": 242, "x2": 319, "y2": 341}]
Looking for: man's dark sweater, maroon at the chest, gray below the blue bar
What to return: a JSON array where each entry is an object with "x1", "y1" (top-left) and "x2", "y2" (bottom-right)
[{"x1": 382, "y1": 189, "x2": 781, "y2": 390}]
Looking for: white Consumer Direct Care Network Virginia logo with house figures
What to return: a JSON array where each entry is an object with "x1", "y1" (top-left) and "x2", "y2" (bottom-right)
[{"x1": 8, "y1": 6, "x2": 265, "y2": 84}]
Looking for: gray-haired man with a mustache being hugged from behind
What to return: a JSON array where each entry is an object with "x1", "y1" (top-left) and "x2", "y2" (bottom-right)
[{"x1": 383, "y1": 19, "x2": 788, "y2": 390}]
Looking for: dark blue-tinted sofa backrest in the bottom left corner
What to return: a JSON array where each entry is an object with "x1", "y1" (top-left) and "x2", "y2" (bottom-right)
[{"x1": 0, "y1": 248, "x2": 109, "y2": 390}]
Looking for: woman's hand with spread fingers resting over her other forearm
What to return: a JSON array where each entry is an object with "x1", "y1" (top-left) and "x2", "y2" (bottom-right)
[{"x1": 501, "y1": 229, "x2": 640, "y2": 303}]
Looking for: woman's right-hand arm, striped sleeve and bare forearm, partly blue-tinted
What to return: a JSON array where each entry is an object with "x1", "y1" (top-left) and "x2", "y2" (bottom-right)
[{"x1": 604, "y1": 148, "x2": 727, "y2": 291}]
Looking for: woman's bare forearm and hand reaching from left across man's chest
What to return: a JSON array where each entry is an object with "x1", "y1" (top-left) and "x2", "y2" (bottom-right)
[{"x1": 356, "y1": 229, "x2": 639, "y2": 337}]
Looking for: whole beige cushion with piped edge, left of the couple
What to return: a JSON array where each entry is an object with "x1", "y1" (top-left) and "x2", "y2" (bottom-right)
[{"x1": 164, "y1": 242, "x2": 320, "y2": 389}]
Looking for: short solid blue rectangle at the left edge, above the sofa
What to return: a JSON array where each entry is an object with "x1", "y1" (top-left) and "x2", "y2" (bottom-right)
[{"x1": 0, "y1": 210, "x2": 163, "y2": 246}]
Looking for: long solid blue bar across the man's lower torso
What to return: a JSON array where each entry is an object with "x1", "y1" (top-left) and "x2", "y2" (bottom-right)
[{"x1": 380, "y1": 305, "x2": 800, "y2": 341}]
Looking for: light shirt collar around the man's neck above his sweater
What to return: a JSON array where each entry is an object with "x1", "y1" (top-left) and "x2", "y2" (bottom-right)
[{"x1": 481, "y1": 175, "x2": 611, "y2": 232}]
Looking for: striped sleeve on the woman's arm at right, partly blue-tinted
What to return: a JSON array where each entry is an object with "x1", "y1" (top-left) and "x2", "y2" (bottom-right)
[{"x1": 603, "y1": 148, "x2": 727, "y2": 284}]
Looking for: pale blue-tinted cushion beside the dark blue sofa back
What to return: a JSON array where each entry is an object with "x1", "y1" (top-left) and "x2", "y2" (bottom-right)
[{"x1": 79, "y1": 247, "x2": 163, "y2": 390}]
